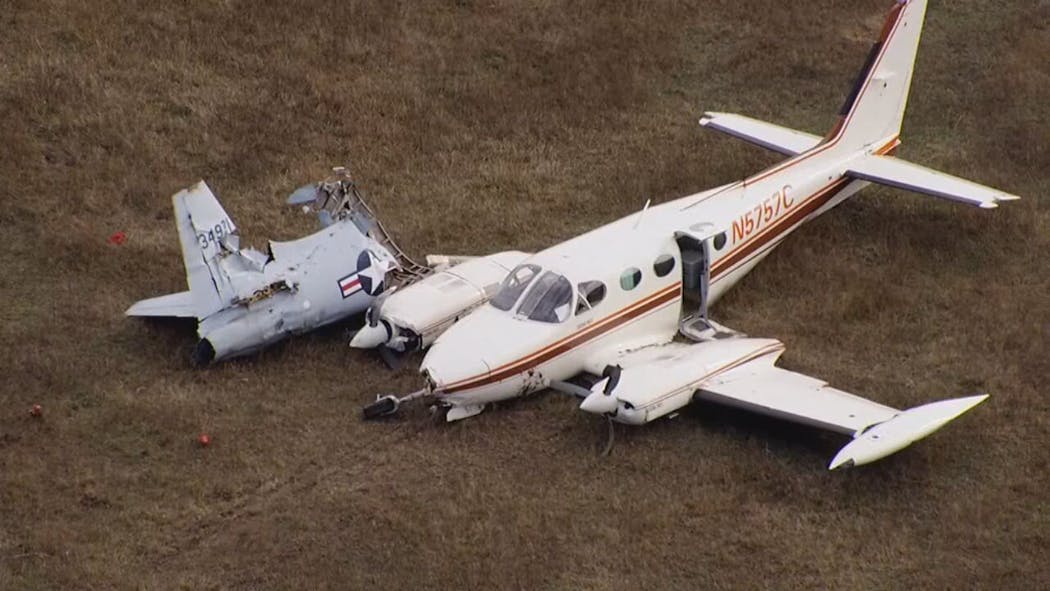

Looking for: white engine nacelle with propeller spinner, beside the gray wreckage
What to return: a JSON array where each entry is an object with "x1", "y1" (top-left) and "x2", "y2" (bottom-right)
[{"x1": 350, "y1": 251, "x2": 529, "y2": 353}]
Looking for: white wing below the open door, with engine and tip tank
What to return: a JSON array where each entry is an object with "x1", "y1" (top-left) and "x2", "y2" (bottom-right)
[{"x1": 580, "y1": 337, "x2": 987, "y2": 469}]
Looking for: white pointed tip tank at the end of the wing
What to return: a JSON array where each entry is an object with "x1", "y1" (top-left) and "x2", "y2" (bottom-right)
[{"x1": 827, "y1": 394, "x2": 988, "y2": 470}]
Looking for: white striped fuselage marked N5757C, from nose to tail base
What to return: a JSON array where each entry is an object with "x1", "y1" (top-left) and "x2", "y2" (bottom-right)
[{"x1": 421, "y1": 132, "x2": 899, "y2": 406}]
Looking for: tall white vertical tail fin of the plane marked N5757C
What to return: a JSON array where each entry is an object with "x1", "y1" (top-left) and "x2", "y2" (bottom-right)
[{"x1": 824, "y1": 0, "x2": 926, "y2": 150}]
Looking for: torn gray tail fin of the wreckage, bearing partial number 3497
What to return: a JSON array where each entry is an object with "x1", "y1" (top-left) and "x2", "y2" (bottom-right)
[{"x1": 171, "y1": 181, "x2": 238, "y2": 318}]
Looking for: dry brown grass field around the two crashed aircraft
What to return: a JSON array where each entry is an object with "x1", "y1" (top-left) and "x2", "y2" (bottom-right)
[{"x1": 0, "y1": 0, "x2": 1050, "y2": 589}]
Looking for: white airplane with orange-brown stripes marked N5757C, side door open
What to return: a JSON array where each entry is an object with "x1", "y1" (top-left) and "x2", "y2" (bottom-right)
[{"x1": 365, "y1": 0, "x2": 1017, "y2": 469}]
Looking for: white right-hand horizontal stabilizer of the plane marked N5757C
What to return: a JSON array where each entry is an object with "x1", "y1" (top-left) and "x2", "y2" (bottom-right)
[{"x1": 846, "y1": 155, "x2": 1021, "y2": 209}]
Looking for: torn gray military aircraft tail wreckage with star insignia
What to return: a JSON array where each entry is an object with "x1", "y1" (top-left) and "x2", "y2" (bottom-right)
[{"x1": 125, "y1": 168, "x2": 427, "y2": 365}]
